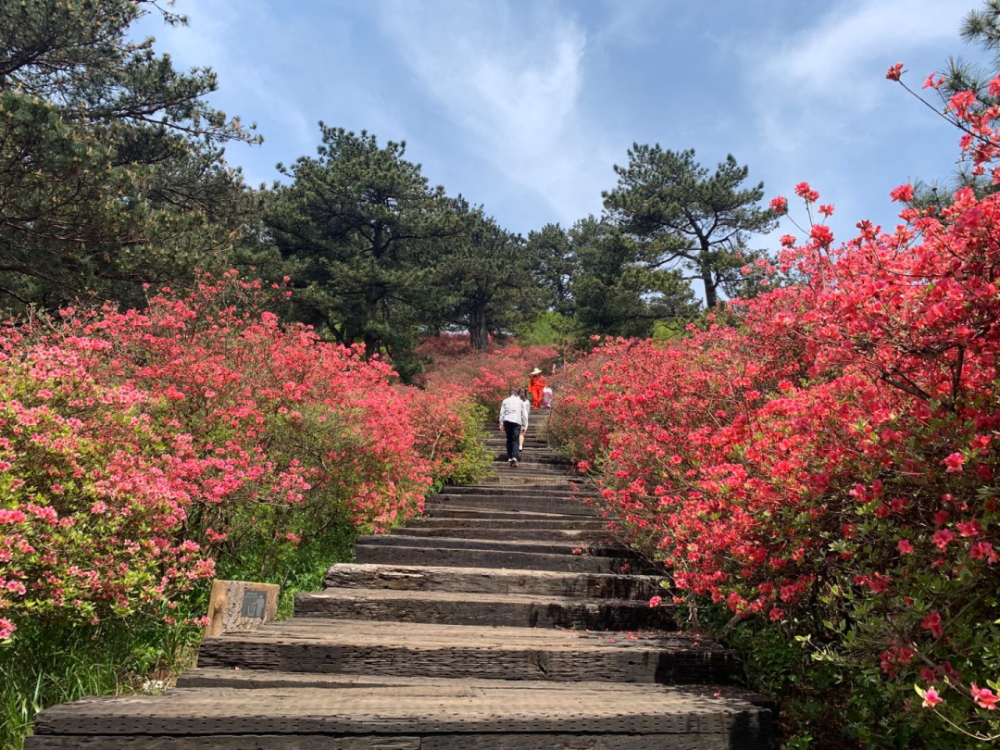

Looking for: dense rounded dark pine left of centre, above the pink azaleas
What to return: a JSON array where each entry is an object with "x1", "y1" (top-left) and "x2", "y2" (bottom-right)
[{"x1": 266, "y1": 123, "x2": 461, "y2": 357}]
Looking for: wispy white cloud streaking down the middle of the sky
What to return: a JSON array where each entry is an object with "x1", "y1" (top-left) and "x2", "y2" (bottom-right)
[{"x1": 380, "y1": 0, "x2": 610, "y2": 221}]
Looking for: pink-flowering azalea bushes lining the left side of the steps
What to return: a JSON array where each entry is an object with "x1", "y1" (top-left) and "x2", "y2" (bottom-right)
[{"x1": 0, "y1": 272, "x2": 483, "y2": 746}]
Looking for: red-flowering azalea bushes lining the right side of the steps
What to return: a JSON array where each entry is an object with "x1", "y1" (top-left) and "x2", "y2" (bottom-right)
[{"x1": 550, "y1": 68, "x2": 1000, "y2": 747}]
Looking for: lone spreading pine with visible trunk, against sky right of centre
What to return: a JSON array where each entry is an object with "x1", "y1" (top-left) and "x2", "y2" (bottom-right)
[{"x1": 603, "y1": 143, "x2": 776, "y2": 307}]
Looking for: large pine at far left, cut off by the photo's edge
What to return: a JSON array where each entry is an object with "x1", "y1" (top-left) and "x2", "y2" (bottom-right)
[{"x1": 0, "y1": 0, "x2": 256, "y2": 308}]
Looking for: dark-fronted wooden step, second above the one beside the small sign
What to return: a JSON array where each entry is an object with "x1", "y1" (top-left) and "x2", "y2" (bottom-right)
[{"x1": 354, "y1": 544, "x2": 637, "y2": 573}]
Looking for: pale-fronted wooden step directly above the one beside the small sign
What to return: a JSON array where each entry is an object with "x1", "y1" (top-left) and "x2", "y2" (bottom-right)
[{"x1": 323, "y1": 563, "x2": 664, "y2": 601}]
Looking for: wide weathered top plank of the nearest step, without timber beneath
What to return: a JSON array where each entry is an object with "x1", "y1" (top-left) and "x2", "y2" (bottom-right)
[{"x1": 29, "y1": 684, "x2": 770, "y2": 737}]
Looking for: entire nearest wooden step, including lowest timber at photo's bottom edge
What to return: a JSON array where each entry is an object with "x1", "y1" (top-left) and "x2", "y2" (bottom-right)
[{"x1": 26, "y1": 675, "x2": 772, "y2": 750}]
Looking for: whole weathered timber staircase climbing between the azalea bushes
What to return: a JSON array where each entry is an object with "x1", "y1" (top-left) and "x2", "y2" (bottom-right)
[{"x1": 26, "y1": 412, "x2": 773, "y2": 750}]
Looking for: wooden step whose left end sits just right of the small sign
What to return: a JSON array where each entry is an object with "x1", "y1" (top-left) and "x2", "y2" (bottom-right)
[{"x1": 295, "y1": 589, "x2": 675, "y2": 630}]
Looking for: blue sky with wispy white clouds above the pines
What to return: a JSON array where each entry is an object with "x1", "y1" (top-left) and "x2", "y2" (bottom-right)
[{"x1": 135, "y1": 0, "x2": 982, "y2": 247}]
